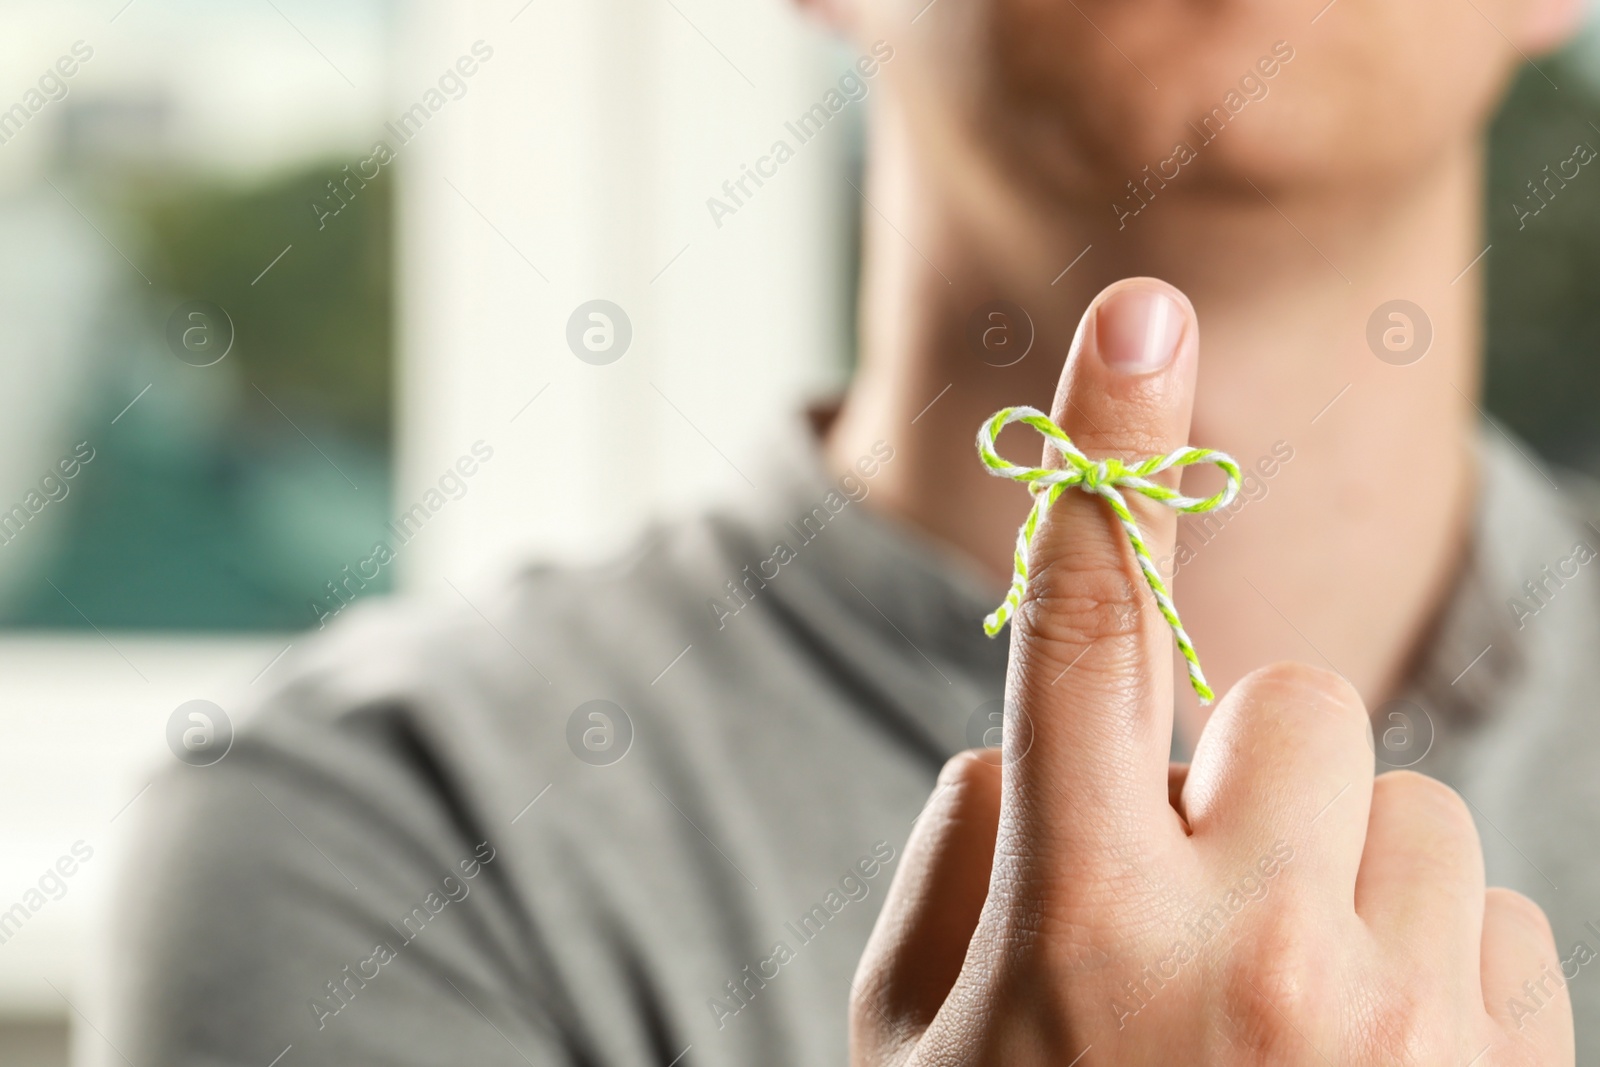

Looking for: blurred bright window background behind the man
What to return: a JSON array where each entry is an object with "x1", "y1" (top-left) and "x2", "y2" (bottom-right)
[{"x1": 0, "y1": 0, "x2": 1600, "y2": 1067}]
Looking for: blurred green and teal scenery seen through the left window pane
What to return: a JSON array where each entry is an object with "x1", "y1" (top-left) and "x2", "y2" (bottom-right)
[{"x1": 0, "y1": 162, "x2": 394, "y2": 630}]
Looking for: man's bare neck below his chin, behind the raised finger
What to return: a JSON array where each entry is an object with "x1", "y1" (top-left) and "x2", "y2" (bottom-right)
[{"x1": 826, "y1": 102, "x2": 1483, "y2": 731}]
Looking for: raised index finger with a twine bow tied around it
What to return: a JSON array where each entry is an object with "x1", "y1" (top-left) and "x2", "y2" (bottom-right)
[{"x1": 1003, "y1": 278, "x2": 1200, "y2": 873}]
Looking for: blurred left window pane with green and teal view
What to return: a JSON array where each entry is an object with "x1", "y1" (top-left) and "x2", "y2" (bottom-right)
[{"x1": 0, "y1": 0, "x2": 394, "y2": 630}]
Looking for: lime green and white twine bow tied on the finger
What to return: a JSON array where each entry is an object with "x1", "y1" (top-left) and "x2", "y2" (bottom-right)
[{"x1": 978, "y1": 408, "x2": 1240, "y2": 704}]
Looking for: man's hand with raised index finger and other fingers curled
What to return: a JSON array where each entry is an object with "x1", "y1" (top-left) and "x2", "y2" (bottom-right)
[{"x1": 851, "y1": 278, "x2": 1573, "y2": 1067}]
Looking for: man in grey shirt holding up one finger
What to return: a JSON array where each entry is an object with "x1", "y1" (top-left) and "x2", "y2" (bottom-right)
[{"x1": 100, "y1": 0, "x2": 1600, "y2": 1065}]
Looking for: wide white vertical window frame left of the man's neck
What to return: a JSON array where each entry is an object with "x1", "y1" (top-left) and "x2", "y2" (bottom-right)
[{"x1": 397, "y1": 0, "x2": 861, "y2": 587}]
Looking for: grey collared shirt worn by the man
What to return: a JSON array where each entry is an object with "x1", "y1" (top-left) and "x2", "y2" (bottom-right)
[{"x1": 93, "y1": 430, "x2": 1600, "y2": 1067}]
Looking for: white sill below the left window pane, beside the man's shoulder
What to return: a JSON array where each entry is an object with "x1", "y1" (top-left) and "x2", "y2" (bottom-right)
[{"x1": 0, "y1": 633, "x2": 286, "y2": 1024}]
